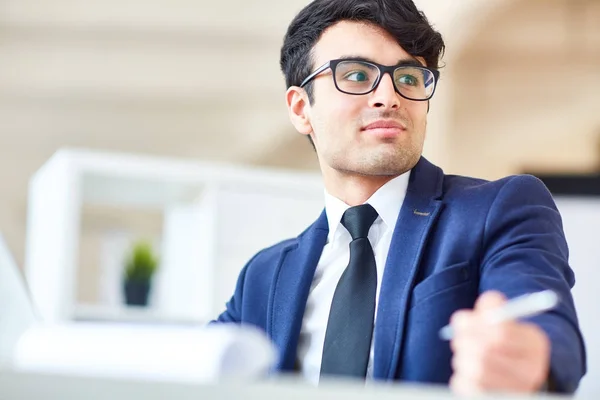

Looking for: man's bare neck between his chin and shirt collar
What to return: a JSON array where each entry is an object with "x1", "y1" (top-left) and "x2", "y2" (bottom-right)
[{"x1": 323, "y1": 170, "x2": 397, "y2": 207}]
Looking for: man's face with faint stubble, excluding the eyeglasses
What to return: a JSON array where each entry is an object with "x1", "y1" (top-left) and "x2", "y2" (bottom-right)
[{"x1": 295, "y1": 21, "x2": 427, "y2": 176}]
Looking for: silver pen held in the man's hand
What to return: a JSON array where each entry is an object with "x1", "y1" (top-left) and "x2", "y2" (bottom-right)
[{"x1": 439, "y1": 290, "x2": 559, "y2": 340}]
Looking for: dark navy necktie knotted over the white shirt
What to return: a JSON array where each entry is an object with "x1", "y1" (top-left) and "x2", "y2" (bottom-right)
[{"x1": 321, "y1": 204, "x2": 377, "y2": 378}]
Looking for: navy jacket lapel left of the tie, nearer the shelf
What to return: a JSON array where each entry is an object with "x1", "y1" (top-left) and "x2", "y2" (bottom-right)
[{"x1": 267, "y1": 211, "x2": 329, "y2": 371}]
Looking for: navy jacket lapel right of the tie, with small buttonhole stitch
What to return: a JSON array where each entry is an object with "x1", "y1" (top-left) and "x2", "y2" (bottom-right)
[{"x1": 373, "y1": 158, "x2": 443, "y2": 380}]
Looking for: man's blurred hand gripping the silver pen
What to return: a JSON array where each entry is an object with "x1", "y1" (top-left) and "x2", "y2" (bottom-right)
[{"x1": 450, "y1": 292, "x2": 550, "y2": 394}]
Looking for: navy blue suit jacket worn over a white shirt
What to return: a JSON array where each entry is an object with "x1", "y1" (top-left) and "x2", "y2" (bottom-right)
[{"x1": 217, "y1": 158, "x2": 586, "y2": 392}]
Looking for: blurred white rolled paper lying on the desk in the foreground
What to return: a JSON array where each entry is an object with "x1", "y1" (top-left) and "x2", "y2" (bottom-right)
[{"x1": 13, "y1": 323, "x2": 276, "y2": 383}]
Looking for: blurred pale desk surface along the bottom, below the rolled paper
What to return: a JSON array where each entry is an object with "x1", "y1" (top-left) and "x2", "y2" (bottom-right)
[{"x1": 0, "y1": 370, "x2": 564, "y2": 400}]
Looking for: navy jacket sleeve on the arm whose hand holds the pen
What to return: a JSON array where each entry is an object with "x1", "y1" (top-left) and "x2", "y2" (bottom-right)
[{"x1": 480, "y1": 175, "x2": 586, "y2": 393}]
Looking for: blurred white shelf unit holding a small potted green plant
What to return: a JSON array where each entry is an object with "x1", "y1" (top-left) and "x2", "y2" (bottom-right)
[{"x1": 25, "y1": 149, "x2": 323, "y2": 323}]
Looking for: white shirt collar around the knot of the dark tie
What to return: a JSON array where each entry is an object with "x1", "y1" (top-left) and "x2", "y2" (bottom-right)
[{"x1": 325, "y1": 171, "x2": 410, "y2": 243}]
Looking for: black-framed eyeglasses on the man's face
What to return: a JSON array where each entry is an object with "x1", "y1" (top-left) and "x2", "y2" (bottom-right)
[{"x1": 300, "y1": 59, "x2": 440, "y2": 101}]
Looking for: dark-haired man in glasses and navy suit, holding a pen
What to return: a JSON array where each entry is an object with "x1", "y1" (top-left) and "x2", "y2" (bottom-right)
[{"x1": 213, "y1": 0, "x2": 586, "y2": 393}]
